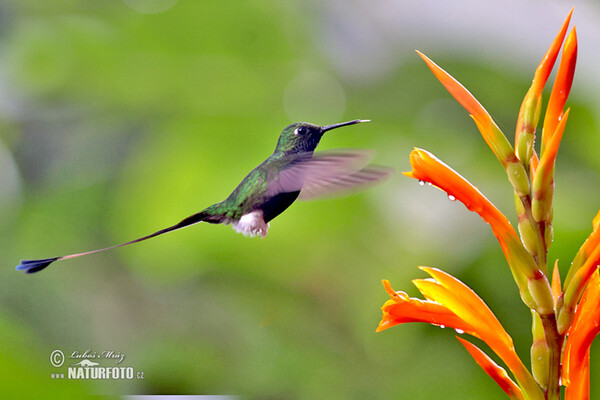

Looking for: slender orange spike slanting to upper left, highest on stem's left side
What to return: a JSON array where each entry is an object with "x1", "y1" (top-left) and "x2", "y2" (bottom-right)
[{"x1": 417, "y1": 51, "x2": 529, "y2": 195}]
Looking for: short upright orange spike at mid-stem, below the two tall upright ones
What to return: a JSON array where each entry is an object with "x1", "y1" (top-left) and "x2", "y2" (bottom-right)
[{"x1": 531, "y1": 109, "x2": 570, "y2": 222}]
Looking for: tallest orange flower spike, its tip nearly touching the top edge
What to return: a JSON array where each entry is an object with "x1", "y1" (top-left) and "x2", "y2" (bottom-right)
[{"x1": 515, "y1": 9, "x2": 573, "y2": 164}]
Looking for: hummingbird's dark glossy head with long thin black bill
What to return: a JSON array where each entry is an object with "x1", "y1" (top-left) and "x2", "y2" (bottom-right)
[{"x1": 275, "y1": 119, "x2": 369, "y2": 154}]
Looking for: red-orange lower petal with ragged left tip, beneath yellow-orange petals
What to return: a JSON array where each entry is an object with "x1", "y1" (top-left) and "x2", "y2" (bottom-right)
[{"x1": 377, "y1": 280, "x2": 478, "y2": 337}]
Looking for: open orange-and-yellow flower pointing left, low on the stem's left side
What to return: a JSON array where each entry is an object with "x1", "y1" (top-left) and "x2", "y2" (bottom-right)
[{"x1": 377, "y1": 267, "x2": 543, "y2": 399}]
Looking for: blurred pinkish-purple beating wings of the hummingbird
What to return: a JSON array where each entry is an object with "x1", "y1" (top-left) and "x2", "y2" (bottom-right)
[{"x1": 267, "y1": 150, "x2": 392, "y2": 200}]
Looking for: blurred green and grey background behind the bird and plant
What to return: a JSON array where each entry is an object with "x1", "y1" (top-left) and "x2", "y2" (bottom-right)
[{"x1": 0, "y1": 0, "x2": 600, "y2": 399}]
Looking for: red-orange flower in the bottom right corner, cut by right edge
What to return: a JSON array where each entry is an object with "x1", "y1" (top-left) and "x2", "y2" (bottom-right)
[{"x1": 563, "y1": 270, "x2": 600, "y2": 400}]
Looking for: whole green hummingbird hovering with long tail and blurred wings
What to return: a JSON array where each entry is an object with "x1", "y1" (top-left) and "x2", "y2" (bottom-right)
[{"x1": 16, "y1": 119, "x2": 392, "y2": 274}]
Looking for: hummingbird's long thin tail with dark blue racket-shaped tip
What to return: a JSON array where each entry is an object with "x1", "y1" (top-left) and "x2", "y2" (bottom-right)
[{"x1": 17, "y1": 206, "x2": 220, "y2": 274}]
